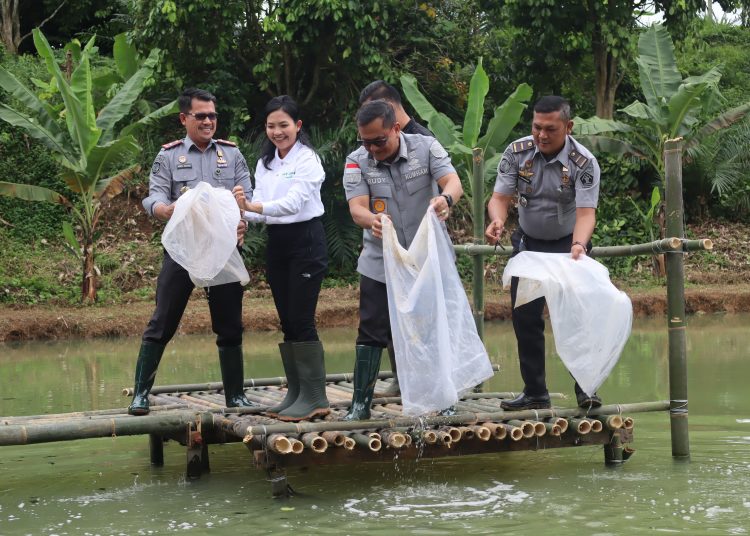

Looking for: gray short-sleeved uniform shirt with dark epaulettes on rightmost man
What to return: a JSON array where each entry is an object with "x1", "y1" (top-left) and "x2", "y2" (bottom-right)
[{"x1": 494, "y1": 136, "x2": 599, "y2": 240}]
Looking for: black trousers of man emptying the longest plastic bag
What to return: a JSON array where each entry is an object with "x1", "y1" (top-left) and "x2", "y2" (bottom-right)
[{"x1": 357, "y1": 275, "x2": 391, "y2": 348}]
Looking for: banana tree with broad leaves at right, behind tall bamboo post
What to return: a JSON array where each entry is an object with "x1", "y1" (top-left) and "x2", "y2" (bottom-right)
[{"x1": 573, "y1": 25, "x2": 750, "y2": 192}]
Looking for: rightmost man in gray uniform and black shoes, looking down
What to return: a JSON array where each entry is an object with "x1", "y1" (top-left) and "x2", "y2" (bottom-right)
[{"x1": 485, "y1": 96, "x2": 601, "y2": 410}]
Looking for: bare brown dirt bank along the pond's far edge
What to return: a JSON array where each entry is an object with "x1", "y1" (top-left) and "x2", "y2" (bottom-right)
[{"x1": 0, "y1": 284, "x2": 750, "y2": 342}]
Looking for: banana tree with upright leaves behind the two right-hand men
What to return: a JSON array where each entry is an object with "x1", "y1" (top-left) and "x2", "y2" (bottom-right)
[{"x1": 401, "y1": 58, "x2": 533, "y2": 209}]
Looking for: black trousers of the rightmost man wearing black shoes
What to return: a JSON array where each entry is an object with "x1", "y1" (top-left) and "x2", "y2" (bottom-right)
[{"x1": 510, "y1": 228, "x2": 591, "y2": 396}]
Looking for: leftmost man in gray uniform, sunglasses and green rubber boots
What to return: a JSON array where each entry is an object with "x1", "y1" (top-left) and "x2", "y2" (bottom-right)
[{"x1": 128, "y1": 88, "x2": 252, "y2": 415}]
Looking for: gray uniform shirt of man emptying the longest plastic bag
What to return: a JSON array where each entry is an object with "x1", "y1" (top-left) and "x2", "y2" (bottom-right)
[{"x1": 344, "y1": 133, "x2": 456, "y2": 283}]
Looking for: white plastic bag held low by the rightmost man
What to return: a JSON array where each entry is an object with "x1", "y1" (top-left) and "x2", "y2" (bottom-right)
[{"x1": 503, "y1": 251, "x2": 633, "y2": 394}]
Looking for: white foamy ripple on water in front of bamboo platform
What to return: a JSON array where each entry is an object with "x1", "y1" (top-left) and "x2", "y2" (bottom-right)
[{"x1": 343, "y1": 481, "x2": 531, "y2": 519}]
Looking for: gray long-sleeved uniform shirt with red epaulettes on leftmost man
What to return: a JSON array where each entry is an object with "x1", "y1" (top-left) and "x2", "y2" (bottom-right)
[{"x1": 143, "y1": 136, "x2": 253, "y2": 216}]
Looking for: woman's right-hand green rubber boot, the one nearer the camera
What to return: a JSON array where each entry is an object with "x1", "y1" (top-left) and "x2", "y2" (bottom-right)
[{"x1": 277, "y1": 341, "x2": 331, "y2": 421}]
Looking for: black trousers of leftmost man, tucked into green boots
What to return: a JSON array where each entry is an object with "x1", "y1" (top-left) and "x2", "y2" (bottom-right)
[{"x1": 143, "y1": 251, "x2": 243, "y2": 347}]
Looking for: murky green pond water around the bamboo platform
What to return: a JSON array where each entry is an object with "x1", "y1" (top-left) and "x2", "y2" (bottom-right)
[{"x1": 0, "y1": 315, "x2": 750, "y2": 535}]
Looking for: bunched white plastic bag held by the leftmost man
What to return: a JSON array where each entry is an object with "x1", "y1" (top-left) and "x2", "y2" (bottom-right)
[{"x1": 161, "y1": 182, "x2": 250, "y2": 287}]
